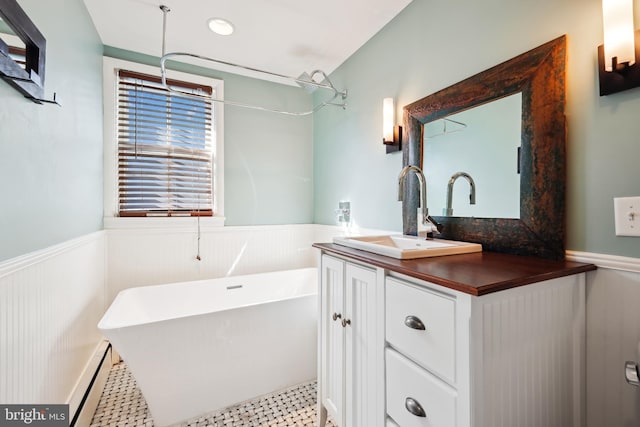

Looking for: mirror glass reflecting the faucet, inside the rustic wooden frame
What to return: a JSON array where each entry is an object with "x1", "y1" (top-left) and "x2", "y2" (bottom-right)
[{"x1": 422, "y1": 92, "x2": 522, "y2": 218}]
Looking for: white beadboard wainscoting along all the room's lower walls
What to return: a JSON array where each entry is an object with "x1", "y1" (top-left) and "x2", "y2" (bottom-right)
[{"x1": 0, "y1": 223, "x2": 640, "y2": 427}]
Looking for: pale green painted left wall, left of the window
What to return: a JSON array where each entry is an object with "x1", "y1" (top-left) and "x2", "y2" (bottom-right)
[{"x1": 0, "y1": 0, "x2": 103, "y2": 261}]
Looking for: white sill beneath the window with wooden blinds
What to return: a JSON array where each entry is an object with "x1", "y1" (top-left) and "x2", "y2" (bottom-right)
[{"x1": 104, "y1": 216, "x2": 225, "y2": 231}]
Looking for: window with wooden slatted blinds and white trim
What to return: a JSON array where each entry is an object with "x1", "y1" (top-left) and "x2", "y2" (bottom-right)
[{"x1": 103, "y1": 56, "x2": 224, "y2": 230}]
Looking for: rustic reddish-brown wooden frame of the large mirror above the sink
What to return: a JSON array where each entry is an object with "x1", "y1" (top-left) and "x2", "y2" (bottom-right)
[{"x1": 402, "y1": 35, "x2": 566, "y2": 259}]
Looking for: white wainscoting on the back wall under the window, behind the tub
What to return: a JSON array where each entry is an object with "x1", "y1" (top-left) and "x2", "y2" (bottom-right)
[{"x1": 107, "y1": 221, "x2": 317, "y2": 302}]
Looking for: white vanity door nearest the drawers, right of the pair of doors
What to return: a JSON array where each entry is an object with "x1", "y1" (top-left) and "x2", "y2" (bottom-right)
[{"x1": 344, "y1": 263, "x2": 385, "y2": 427}]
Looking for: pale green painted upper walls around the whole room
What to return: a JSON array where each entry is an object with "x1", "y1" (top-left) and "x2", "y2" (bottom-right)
[{"x1": 0, "y1": 0, "x2": 640, "y2": 260}]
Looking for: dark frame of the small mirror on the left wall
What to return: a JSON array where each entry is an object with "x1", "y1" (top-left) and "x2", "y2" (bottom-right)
[{"x1": 0, "y1": 0, "x2": 46, "y2": 102}]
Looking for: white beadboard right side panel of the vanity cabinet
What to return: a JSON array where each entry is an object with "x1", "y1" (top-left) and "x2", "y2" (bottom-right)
[{"x1": 472, "y1": 275, "x2": 585, "y2": 427}]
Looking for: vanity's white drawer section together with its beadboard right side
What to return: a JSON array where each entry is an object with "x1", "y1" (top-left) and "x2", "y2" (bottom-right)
[{"x1": 385, "y1": 274, "x2": 585, "y2": 427}]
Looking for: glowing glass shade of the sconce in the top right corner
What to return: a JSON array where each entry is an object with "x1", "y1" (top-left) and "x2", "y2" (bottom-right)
[{"x1": 602, "y1": 0, "x2": 635, "y2": 71}]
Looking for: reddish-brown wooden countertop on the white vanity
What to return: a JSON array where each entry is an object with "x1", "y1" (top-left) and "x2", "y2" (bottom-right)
[{"x1": 313, "y1": 243, "x2": 596, "y2": 296}]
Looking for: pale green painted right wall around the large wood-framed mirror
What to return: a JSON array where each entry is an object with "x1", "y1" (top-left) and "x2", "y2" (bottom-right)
[{"x1": 314, "y1": 0, "x2": 640, "y2": 257}]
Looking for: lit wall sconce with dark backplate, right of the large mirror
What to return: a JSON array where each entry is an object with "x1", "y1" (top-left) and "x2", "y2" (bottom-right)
[{"x1": 598, "y1": 0, "x2": 640, "y2": 96}]
